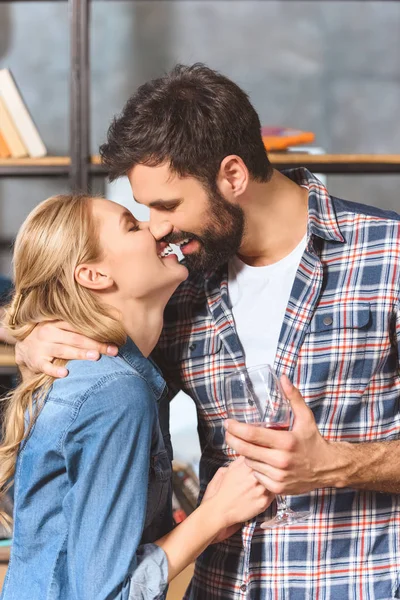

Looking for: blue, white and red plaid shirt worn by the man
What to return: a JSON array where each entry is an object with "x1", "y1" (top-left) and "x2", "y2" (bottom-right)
[{"x1": 157, "y1": 169, "x2": 400, "y2": 600}]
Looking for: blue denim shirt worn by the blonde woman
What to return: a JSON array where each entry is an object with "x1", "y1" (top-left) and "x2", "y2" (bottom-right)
[{"x1": 1, "y1": 340, "x2": 172, "y2": 600}]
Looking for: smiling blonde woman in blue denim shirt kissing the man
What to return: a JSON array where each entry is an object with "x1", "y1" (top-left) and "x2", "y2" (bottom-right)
[{"x1": 0, "y1": 195, "x2": 271, "y2": 600}]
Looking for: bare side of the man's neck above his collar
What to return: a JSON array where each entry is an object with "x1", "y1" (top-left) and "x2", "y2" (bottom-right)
[{"x1": 238, "y1": 170, "x2": 308, "y2": 267}]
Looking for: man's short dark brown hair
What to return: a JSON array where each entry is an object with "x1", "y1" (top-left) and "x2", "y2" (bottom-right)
[{"x1": 100, "y1": 63, "x2": 272, "y2": 190}]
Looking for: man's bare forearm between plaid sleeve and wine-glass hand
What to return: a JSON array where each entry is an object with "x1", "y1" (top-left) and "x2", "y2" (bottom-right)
[{"x1": 330, "y1": 440, "x2": 400, "y2": 494}]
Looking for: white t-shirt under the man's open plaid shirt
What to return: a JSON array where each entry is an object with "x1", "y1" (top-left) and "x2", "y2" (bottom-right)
[{"x1": 228, "y1": 235, "x2": 307, "y2": 367}]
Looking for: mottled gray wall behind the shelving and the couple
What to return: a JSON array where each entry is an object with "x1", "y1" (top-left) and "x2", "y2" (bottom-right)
[{"x1": 0, "y1": 0, "x2": 400, "y2": 271}]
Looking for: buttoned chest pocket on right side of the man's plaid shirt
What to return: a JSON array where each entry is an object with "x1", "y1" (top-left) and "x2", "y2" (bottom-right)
[{"x1": 299, "y1": 302, "x2": 372, "y2": 390}]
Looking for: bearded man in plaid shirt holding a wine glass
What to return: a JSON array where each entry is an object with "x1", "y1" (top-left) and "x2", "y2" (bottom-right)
[{"x1": 10, "y1": 65, "x2": 400, "y2": 600}]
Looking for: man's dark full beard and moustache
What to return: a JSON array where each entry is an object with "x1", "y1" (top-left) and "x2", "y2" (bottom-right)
[{"x1": 164, "y1": 192, "x2": 245, "y2": 273}]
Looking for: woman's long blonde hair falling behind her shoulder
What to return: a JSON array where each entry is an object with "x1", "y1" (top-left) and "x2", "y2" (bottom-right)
[{"x1": 0, "y1": 194, "x2": 126, "y2": 523}]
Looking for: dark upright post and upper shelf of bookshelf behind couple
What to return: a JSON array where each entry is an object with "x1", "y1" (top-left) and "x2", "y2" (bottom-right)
[{"x1": 0, "y1": 0, "x2": 400, "y2": 186}]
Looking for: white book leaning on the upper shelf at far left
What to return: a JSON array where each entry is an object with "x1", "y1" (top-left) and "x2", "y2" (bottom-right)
[{"x1": 0, "y1": 69, "x2": 47, "y2": 158}]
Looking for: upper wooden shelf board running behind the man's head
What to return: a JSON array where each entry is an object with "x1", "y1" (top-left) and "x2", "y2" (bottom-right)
[{"x1": 0, "y1": 152, "x2": 400, "y2": 177}]
